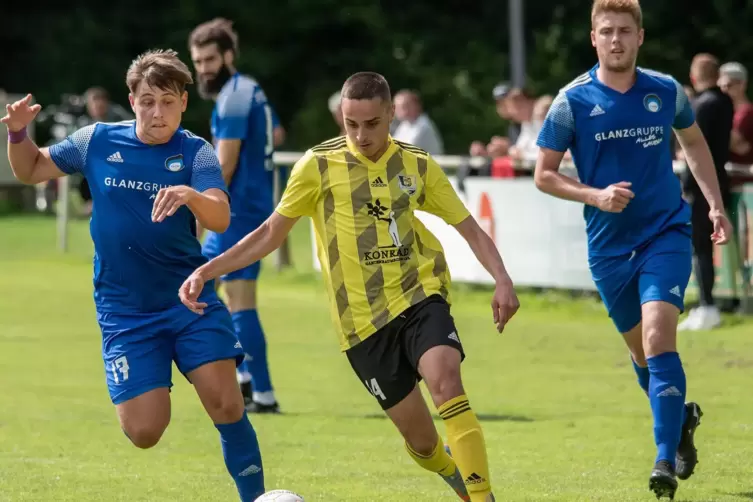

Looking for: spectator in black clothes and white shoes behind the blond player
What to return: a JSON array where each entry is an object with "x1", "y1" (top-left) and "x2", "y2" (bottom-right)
[{"x1": 678, "y1": 54, "x2": 734, "y2": 330}]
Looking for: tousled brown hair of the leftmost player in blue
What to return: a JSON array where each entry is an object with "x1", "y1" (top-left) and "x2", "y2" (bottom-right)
[{"x1": 126, "y1": 49, "x2": 193, "y2": 94}]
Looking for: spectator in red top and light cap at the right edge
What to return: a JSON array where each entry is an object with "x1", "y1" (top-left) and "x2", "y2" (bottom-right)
[{"x1": 719, "y1": 63, "x2": 753, "y2": 165}]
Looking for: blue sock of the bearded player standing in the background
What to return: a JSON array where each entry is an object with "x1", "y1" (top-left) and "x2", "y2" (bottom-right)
[{"x1": 233, "y1": 309, "x2": 272, "y2": 392}]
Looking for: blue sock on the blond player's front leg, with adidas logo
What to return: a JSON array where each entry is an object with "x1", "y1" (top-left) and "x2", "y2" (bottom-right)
[{"x1": 647, "y1": 352, "x2": 686, "y2": 467}]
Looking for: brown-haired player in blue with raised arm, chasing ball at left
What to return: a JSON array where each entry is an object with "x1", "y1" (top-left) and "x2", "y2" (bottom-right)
[{"x1": 2, "y1": 51, "x2": 264, "y2": 502}]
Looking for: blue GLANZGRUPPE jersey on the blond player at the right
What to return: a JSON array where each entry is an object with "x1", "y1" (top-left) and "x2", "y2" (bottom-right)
[{"x1": 537, "y1": 65, "x2": 695, "y2": 257}]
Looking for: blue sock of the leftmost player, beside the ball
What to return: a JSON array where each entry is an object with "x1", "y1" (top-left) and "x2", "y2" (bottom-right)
[{"x1": 214, "y1": 413, "x2": 264, "y2": 502}]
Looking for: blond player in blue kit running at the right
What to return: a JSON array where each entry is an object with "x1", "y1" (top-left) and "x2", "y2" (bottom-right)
[{"x1": 535, "y1": 0, "x2": 731, "y2": 498}]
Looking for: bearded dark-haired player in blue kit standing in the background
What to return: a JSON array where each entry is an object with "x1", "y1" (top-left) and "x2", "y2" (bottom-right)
[{"x1": 188, "y1": 18, "x2": 279, "y2": 413}]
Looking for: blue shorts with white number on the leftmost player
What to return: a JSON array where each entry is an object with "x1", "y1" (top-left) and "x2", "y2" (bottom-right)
[{"x1": 97, "y1": 300, "x2": 244, "y2": 404}]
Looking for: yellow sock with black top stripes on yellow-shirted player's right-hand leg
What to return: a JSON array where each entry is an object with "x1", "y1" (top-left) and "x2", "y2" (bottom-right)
[{"x1": 439, "y1": 396, "x2": 494, "y2": 502}]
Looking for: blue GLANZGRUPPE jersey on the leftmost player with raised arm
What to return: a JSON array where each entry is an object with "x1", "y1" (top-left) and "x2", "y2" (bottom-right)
[{"x1": 50, "y1": 120, "x2": 225, "y2": 312}]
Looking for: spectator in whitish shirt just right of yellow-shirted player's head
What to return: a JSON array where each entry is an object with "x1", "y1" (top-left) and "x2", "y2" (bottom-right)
[{"x1": 392, "y1": 90, "x2": 444, "y2": 155}]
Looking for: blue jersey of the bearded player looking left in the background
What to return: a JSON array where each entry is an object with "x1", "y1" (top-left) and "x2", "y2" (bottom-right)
[{"x1": 212, "y1": 73, "x2": 279, "y2": 220}]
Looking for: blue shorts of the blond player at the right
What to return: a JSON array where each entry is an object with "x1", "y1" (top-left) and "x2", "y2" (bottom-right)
[{"x1": 590, "y1": 225, "x2": 693, "y2": 333}]
